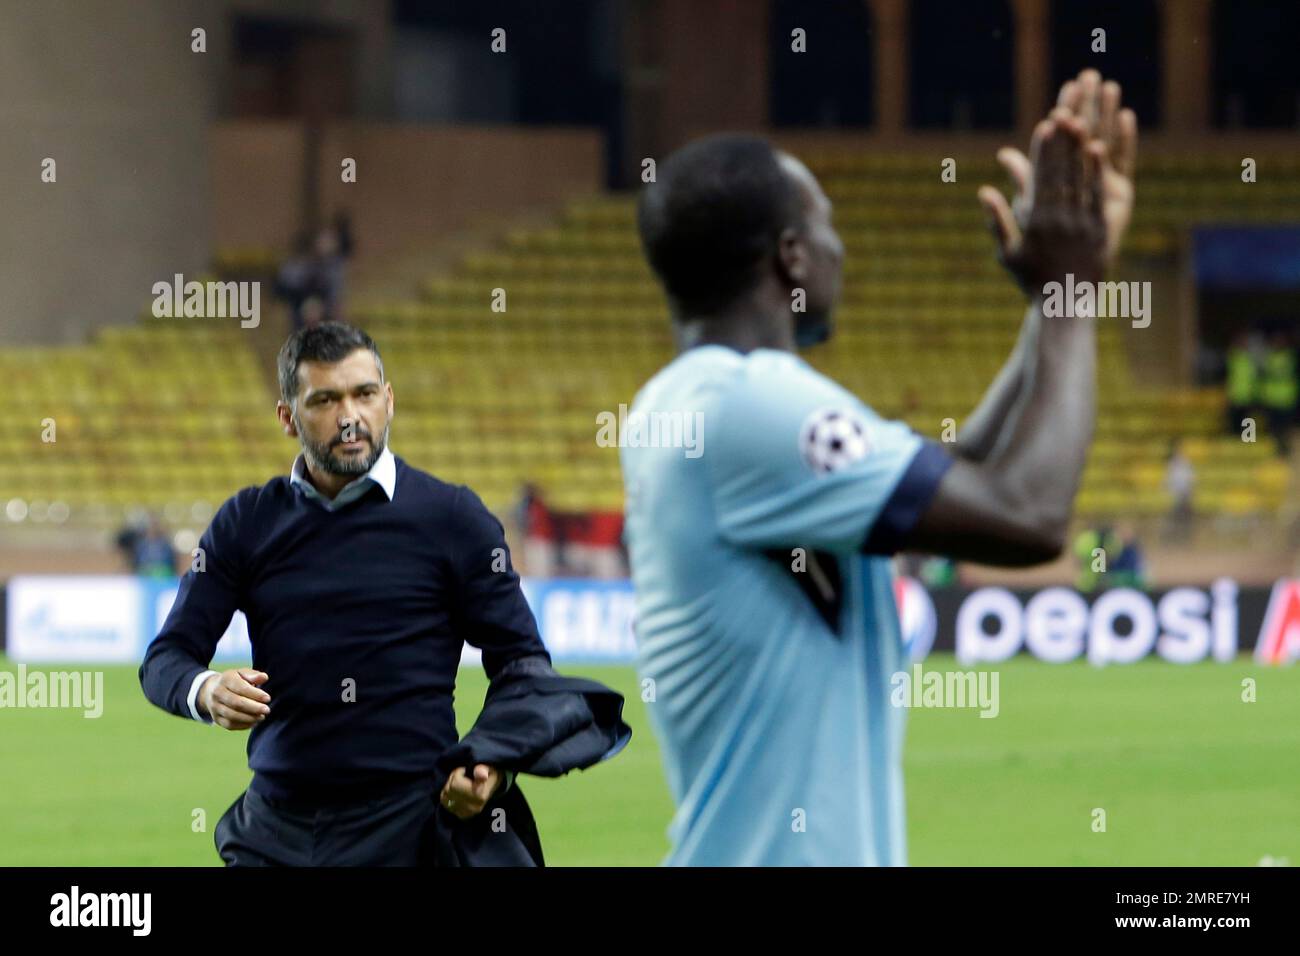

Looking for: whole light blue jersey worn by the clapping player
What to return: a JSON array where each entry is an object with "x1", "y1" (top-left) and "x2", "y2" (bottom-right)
[{"x1": 621, "y1": 346, "x2": 950, "y2": 866}]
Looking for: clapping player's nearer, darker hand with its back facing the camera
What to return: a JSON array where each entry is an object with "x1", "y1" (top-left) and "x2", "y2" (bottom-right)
[{"x1": 980, "y1": 107, "x2": 1106, "y2": 295}]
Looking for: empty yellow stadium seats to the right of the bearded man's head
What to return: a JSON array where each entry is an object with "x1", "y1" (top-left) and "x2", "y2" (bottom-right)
[{"x1": 351, "y1": 152, "x2": 1300, "y2": 518}]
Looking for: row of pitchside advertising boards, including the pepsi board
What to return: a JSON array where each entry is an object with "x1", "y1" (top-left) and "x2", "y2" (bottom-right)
[{"x1": 5, "y1": 576, "x2": 1300, "y2": 666}]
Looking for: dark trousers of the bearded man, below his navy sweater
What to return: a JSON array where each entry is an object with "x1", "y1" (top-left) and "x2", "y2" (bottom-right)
[{"x1": 213, "y1": 779, "x2": 438, "y2": 866}]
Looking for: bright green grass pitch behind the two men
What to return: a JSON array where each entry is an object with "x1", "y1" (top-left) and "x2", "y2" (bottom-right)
[{"x1": 0, "y1": 656, "x2": 1300, "y2": 866}]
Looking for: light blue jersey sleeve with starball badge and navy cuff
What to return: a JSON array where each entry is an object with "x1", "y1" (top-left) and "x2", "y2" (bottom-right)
[{"x1": 702, "y1": 354, "x2": 952, "y2": 554}]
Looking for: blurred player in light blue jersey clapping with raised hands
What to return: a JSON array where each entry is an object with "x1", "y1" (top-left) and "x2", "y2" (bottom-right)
[{"x1": 620, "y1": 72, "x2": 1136, "y2": 865}]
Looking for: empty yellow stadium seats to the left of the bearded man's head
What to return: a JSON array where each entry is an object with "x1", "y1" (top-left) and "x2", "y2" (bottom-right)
[{"x1": 0, "y1": 320, "x2": 286, "y2": 538}]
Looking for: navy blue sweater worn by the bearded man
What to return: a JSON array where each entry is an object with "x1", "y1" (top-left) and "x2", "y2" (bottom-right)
[{"x1": 140, "y1": 458, "x2": 549, "y2": 803}]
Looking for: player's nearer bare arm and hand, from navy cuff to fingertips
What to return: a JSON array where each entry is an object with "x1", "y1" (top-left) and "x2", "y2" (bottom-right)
[{"x1": 907, "y1": 114, "x2": 1108, "y2": 566}]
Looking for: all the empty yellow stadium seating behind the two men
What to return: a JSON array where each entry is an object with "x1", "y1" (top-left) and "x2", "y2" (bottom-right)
[{"x1": 0, "y1": 152, "x2": 1300, "y2": 541}]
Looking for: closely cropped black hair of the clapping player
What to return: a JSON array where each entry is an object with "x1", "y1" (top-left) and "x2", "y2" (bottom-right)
[{"x1": 637, "y1": 134, "x2": 801, "y2": 311}]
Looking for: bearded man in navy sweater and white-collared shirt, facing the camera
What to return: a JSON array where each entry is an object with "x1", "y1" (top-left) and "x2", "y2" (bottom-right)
[{"x1": 140, "y1": 323, "x2": 550, "y2": 866}]
